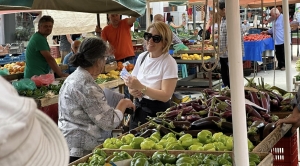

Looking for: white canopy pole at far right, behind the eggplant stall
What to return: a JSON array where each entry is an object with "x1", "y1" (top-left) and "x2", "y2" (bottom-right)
[{"x1": 282, "y1": 0, "x2": 293, "y2": 92}]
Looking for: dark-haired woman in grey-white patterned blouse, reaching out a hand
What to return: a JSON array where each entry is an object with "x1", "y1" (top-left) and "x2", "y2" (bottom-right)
[{"x1": 58, "y1": 38, "x2": 134, "y2": 162}]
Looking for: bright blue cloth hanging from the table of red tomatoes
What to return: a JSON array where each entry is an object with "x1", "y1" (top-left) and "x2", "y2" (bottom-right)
[{"x1": 243, "y1": 38, "x2": 274, "y2": 62}]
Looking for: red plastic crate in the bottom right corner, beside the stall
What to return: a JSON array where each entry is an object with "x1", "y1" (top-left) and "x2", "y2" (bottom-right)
[{"x1": 271, "y1": 132, "x2": 298, "y2": 166}]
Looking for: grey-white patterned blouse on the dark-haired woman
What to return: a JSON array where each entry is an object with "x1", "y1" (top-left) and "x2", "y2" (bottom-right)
[{"x1": 58, "y1": 67, "x2": 123, "y2": 157}]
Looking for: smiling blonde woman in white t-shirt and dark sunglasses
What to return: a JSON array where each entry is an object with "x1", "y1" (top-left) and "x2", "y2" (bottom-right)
[{"x1": 125, "y1": 22, "x2": 178, "y2": 129}]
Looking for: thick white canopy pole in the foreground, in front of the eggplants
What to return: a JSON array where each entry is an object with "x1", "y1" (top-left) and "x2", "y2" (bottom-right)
[{"x1": 225, "y1": 0, "x2": 249, "y2": 166}]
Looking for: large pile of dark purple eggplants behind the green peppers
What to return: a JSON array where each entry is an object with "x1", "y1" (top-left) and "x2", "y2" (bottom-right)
[{"x1": 130, "y1": 89, "x2": 292, "y2": 145}]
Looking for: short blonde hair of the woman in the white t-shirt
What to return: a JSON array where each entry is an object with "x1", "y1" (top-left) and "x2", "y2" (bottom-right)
[{"x1": 147, "y1": 22, "x2": 173, "y2": 54}]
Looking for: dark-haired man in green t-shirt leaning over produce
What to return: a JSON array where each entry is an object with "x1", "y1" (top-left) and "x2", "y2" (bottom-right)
[{"x1": 24, "y1": 16, "x2": 68, "y2": 78}]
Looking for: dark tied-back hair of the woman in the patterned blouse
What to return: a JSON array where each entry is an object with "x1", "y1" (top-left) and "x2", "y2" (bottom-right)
[{"x1": 69, "y1": 37, "x2": 107, "y2": 68}]
